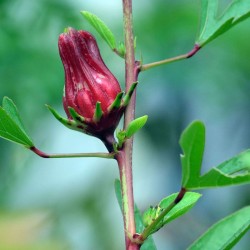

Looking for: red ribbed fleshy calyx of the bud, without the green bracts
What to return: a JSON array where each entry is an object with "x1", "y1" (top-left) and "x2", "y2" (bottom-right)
[{"x1": 58, "y1": 28, "x2": 121, "y2": 119}]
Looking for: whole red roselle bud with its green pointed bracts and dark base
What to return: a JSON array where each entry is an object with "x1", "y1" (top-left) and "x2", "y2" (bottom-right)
[{"x1": 49, "y1": 28, "x2": 136, "y2": 151}]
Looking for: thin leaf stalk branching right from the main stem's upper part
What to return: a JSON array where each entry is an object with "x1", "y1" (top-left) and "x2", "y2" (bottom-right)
[{"x1": 140, "y1": 44, "x2": 201, "y2": 71}]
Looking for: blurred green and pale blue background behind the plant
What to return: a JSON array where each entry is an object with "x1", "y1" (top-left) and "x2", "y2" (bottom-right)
[{"x1": 0, "y1": 0, "x2": 250, "y2": 250}]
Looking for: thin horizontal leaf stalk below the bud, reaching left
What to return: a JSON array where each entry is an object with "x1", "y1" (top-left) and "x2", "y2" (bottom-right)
[{"x1": 30, "y1": 147, "x2": 115, "y2": 159}]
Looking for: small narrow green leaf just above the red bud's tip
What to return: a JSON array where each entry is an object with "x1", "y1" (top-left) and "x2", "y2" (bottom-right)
[{"x1": 81, "y1": 11, "x2": 116, "y2": 50}]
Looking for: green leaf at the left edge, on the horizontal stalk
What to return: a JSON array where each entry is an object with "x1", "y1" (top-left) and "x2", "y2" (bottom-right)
[{"x1": 0, "y1": 97, "x2": 34, "y2": 148}]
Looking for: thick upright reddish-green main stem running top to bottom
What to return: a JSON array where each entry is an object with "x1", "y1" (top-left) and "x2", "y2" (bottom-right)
[{"x1": 118, "y1": 0, "x2": 140, "y2": 250}]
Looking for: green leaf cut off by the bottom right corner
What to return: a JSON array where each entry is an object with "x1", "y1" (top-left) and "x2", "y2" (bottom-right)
[{"x1": 188, "y1": 206, "x2": 250, "y2": 250}]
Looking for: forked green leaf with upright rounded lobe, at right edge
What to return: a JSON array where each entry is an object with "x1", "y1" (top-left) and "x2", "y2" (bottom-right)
[{"x1": 180, "y1": 121, "x2": 250, "y2": 190}]
